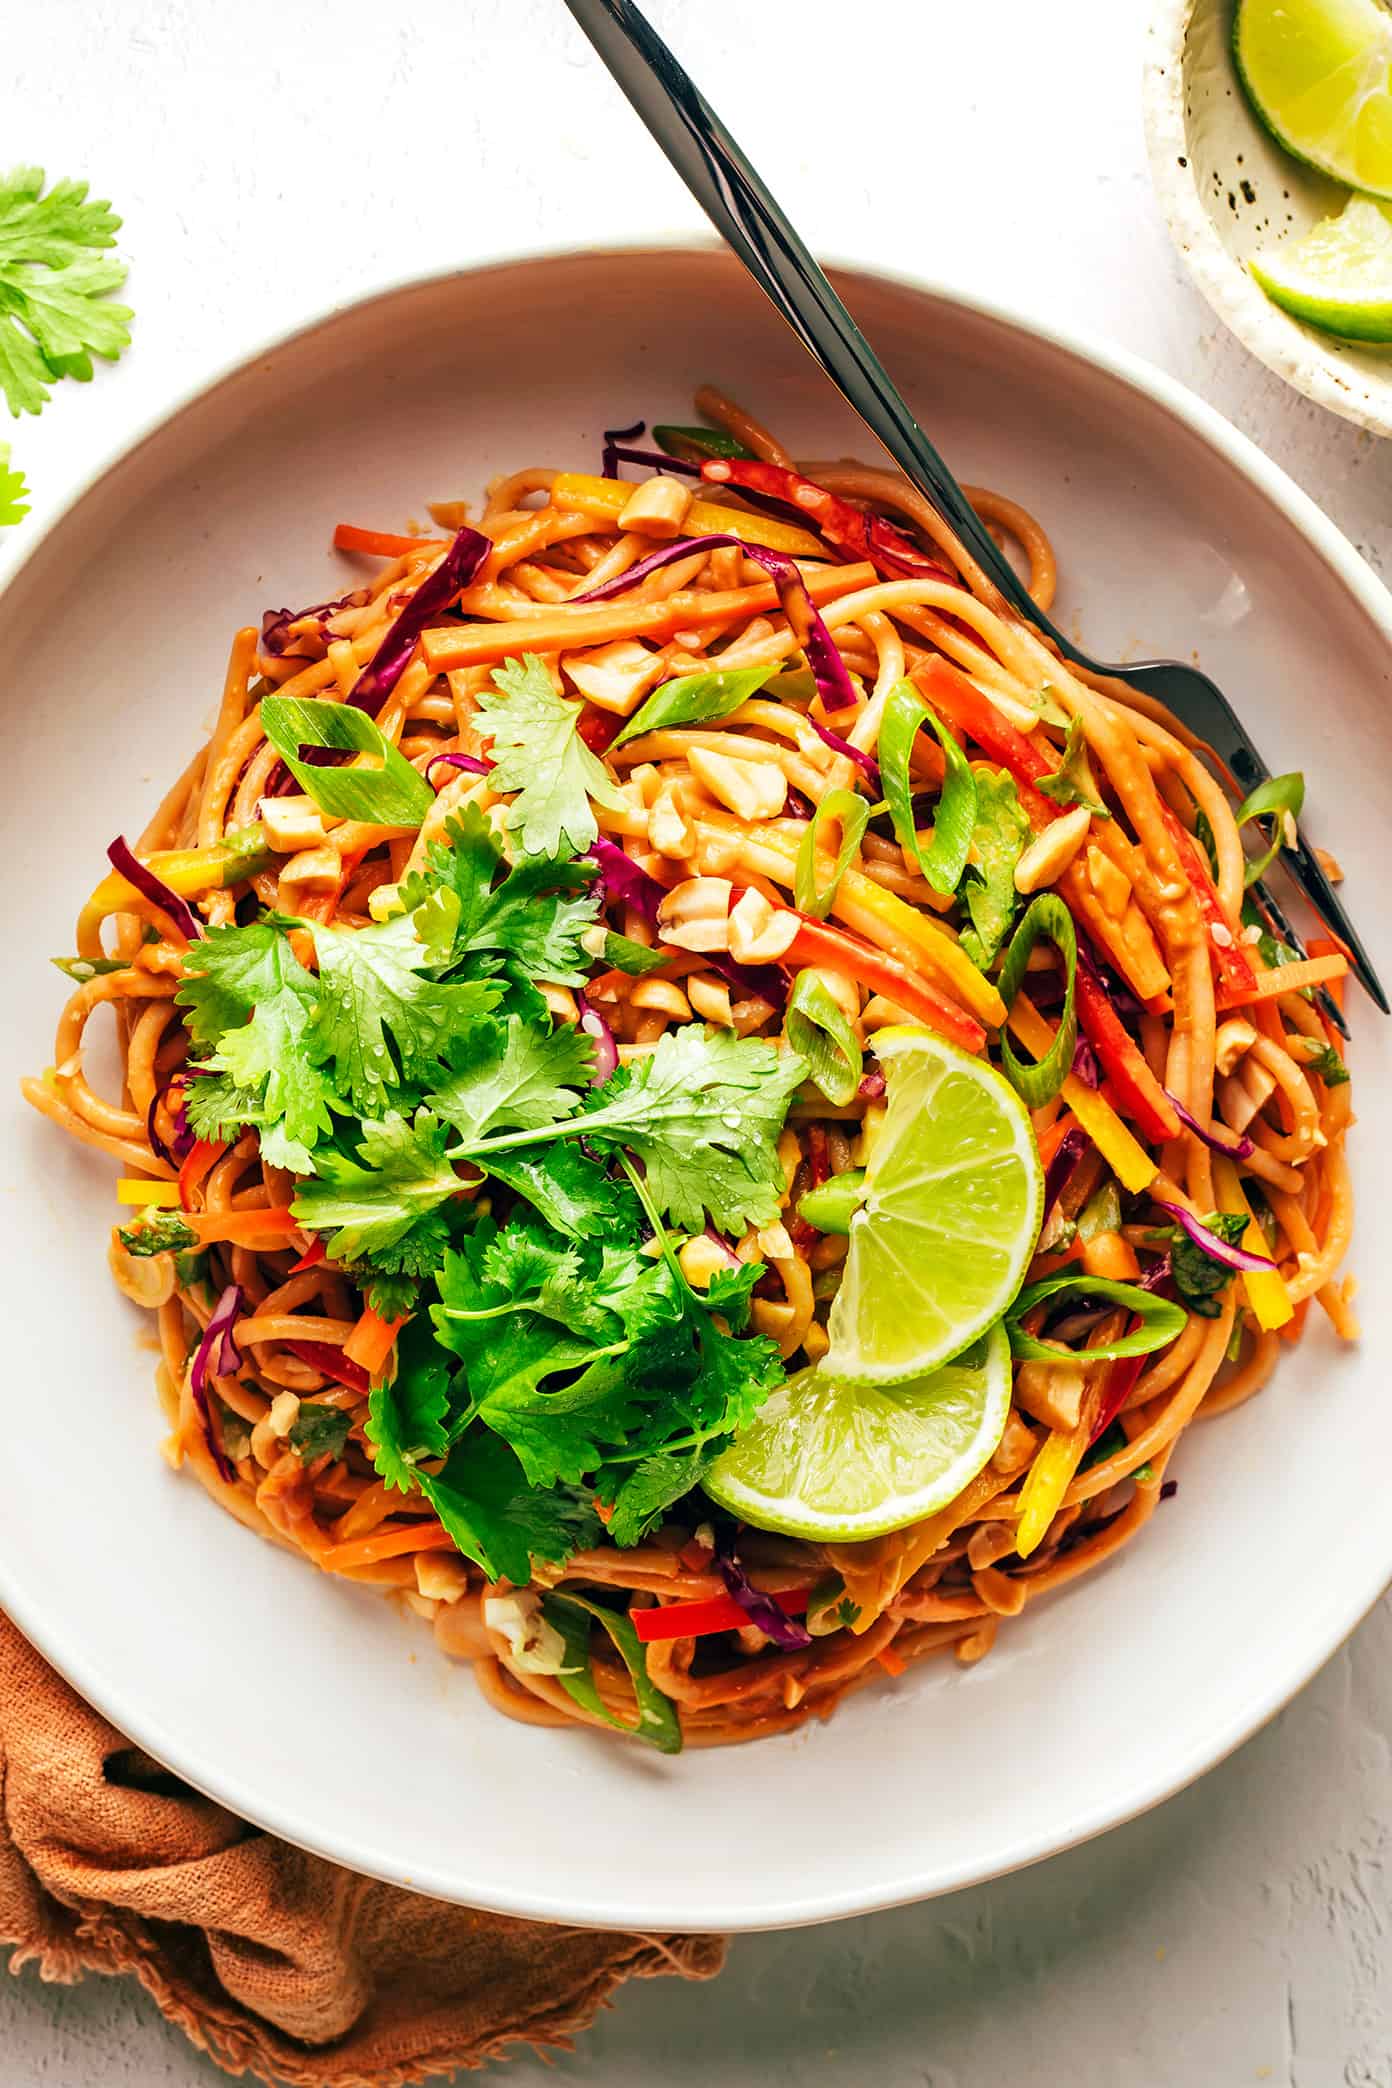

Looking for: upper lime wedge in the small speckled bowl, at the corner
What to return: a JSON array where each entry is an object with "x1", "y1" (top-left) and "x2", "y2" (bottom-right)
[{"x1": 1233, "y1": 0, "x2": 1392, "y2": 196}]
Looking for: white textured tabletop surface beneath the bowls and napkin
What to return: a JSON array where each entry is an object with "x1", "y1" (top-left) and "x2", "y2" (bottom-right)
[{"x1": 0, "y1": 0, "x2": 1392, "y2": 2088}]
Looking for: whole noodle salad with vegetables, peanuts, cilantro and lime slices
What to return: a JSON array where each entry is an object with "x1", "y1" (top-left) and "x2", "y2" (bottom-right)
[{"x1": 25, "y1": 390, "x2": 1357, "y2": 1754}]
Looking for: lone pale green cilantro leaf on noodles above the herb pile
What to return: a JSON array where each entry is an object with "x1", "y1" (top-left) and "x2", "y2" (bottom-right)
[{"x1": 478, "y1": 654, "x2": 624, "y2": 856}]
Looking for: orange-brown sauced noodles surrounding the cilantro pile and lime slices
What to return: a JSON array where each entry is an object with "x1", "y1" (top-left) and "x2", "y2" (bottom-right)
[{"x1": 25, "y1": 390, "x2": 1357, "y2": 1746}]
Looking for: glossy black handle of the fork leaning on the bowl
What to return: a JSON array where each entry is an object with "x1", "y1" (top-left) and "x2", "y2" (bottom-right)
[{"x1": 566, "y1": 0, "x2": 1060, "y2": 634}]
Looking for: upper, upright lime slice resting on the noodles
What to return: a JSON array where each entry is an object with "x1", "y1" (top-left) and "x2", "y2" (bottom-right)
[{"x1": 824, "y1": 1029, "x2": 1043, "y2": 1384}]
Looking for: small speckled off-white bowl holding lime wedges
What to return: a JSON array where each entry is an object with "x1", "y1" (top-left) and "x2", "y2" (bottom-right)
[{"x1": 1144, "y1": 0, "x2": 1392, "y2": 434}]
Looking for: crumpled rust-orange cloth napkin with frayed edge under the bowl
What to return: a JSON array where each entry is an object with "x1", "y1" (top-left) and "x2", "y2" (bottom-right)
[{"x1": 0, "y1": 1616, "x2": 724, "y2": 2088}]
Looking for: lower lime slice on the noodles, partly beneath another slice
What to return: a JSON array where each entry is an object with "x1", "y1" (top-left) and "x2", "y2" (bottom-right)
[{"x1": 701, "y1": 1326, "x2": 1010, "y2": 1543}]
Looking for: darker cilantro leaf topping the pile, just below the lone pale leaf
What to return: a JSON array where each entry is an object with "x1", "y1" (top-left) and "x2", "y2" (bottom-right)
[{"x1": 401, "y1": 804, "x2": 599, "y2": 986}]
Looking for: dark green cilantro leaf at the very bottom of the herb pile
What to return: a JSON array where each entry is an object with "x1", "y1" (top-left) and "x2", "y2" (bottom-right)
[{"x1": 417, "y1": 1430, "x2": 603, "y2": 1587}]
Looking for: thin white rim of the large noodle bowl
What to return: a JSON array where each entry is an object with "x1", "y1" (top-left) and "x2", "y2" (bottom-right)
[{"x1": 0, "y1": 232, "x2": 1392, "y2": 1931}]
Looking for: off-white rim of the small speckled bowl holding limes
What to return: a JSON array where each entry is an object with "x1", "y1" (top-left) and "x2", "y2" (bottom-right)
[{"x1": 1142, "y1": 0, "x2": 1392, "y2": 434}]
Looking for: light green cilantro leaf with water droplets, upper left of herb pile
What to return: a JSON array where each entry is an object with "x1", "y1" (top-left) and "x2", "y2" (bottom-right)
[{"x1": 307, "y1": 904, "x2": 501, "y2": 1117}]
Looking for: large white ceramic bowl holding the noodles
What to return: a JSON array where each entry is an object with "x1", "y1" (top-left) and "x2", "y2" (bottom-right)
[{"x1": 0, "y1": 248, "x2": 1392, "y2": 1929}]
